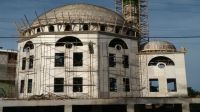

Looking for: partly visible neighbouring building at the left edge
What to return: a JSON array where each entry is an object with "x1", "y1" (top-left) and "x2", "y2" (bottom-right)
[{"x1": 0, "y1": 49, "x2": 17, "y2": 97}]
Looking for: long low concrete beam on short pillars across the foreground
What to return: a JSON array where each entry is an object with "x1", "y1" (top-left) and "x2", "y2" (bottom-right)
[{"x1": 0, "y1": 97, "x2": 196, "y2": 112}]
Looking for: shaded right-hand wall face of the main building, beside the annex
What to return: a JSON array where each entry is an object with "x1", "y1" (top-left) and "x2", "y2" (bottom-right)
[{"x1": 98, "y1": 35, "x2": 138, "y2": 98}]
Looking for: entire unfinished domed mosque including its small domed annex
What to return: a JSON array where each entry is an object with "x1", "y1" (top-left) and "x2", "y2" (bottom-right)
[{"x1": 0, "y1": 0, "x2": 195, "y2": 112}]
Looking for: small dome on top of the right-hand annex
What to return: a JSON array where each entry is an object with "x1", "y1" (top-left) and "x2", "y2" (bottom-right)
[{"x1": 141, "y1": 41, "x2": 176, "y2": 52}]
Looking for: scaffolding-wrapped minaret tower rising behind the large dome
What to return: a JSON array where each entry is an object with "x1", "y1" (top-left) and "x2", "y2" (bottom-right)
[{"x1": 114, "y1": 0, "x2": 149, "y2": 49}]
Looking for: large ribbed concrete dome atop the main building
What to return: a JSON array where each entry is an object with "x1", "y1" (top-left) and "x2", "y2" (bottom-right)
[{"x1": 31, "y1": 4, "x2": 124, "y2": 27}]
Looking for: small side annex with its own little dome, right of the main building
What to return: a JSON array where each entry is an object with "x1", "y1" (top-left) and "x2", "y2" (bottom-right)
[{"x1": 139, "y1": 41, "x2": 187, "y2": 97}]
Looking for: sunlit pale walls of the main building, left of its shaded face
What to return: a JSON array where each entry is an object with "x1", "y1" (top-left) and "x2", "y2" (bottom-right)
[{"x1": 17, "y1": 34, "x2": 98, "y2": 98}]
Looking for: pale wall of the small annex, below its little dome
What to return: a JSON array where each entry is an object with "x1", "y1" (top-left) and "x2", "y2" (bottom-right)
[{"x1": 139, "y1": 52, "x2": 187, "y2": 97}]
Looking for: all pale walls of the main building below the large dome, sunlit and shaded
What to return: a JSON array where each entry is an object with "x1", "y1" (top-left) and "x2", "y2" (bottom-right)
[{"x1": 16, "y1": 33, "x2": 138, "y2": 98}]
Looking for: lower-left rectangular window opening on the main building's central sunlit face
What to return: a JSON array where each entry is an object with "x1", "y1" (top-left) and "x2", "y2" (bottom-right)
[{"x1": 54, "y1": 78, "x2": 64, "y2": 92}]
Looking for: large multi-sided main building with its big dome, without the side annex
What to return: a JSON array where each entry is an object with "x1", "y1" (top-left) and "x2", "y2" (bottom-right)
[{"x1": 16, "y1": 4, "x2": 139, "y2": 99}]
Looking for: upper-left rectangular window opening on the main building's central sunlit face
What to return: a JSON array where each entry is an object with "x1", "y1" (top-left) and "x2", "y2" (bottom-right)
[{"x1": 55, "y1": 53, "x2": 64, "y2": 67}]
